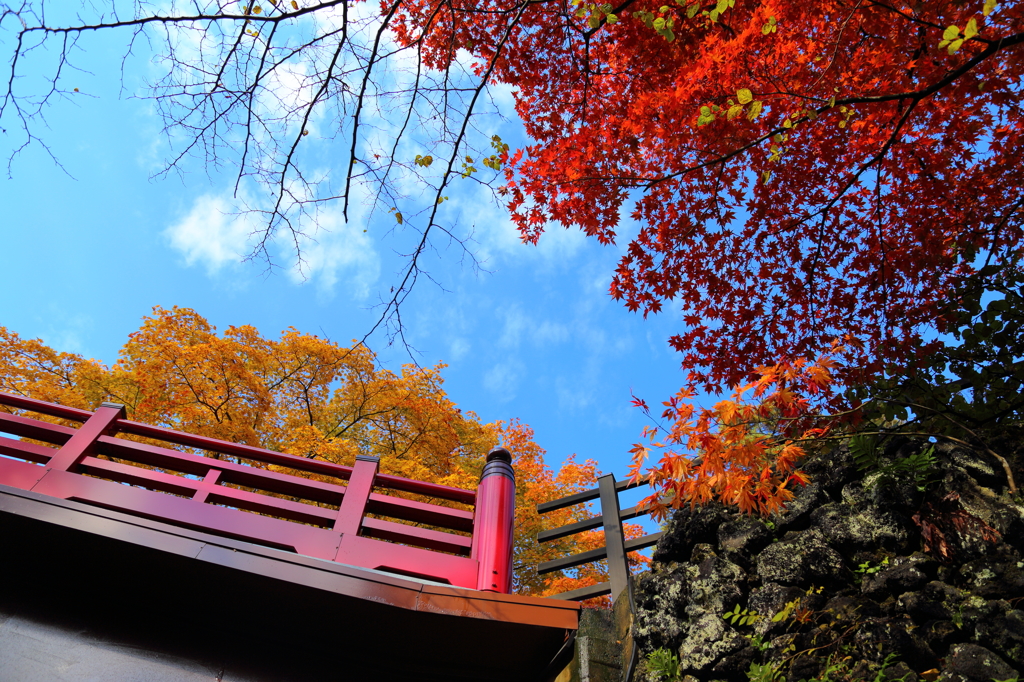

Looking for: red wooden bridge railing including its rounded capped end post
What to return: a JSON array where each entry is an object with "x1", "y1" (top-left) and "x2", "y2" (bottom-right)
[{"x1": 0, "y1": 392, "x2": 515, "y2": 593}]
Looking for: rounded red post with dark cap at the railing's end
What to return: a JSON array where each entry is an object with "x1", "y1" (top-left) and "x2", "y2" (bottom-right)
[{"x1": 470, "y1": 447, "x2": 515, "y2": 594}]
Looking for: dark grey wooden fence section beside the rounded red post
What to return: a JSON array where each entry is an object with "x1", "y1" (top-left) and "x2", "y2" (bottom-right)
[{"x1": 537, "y1": 474, "x2": 662, "y2": 601}]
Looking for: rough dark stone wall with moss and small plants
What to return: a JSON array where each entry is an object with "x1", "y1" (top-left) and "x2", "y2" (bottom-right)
[{"x1": 633, "y1": 438, "x2": 1024, "y2": 682}]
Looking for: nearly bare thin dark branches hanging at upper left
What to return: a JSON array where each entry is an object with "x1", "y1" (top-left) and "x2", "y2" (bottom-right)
[{"x1": 0, "y1": 0, "x2": 520, "y2": 352}]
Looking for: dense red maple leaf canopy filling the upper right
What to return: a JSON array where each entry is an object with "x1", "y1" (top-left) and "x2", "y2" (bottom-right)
[{"x1": 398, "y1": 0, "x2": 1024, "y2": 387}]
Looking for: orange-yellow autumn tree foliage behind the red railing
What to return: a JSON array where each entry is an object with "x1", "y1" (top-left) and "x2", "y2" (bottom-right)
[{"x1": 0, "y1": 307, "x2": 630, "y2": 594}]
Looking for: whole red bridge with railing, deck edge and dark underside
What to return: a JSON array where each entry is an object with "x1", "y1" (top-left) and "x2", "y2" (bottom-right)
[{"x1": 0, "y1": 393, "x2": 579, "y2": 682}]
